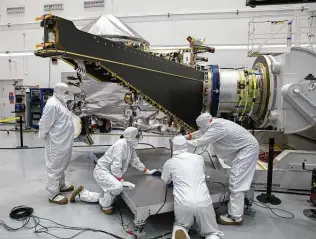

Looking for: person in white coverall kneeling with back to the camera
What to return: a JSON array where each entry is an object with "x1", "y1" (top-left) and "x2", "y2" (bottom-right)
[{"x1": 161, "y1": 135, "x2": 224, "y2": 239}]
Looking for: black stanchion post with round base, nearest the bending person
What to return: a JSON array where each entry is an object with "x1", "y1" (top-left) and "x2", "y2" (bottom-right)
[{"x1": 257, "y1": 138, "x2": 281, "y2": 205}]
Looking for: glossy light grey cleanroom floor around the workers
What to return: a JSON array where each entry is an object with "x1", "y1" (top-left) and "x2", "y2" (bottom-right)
[{"x1": 0, "y1": 132, "x2": 316, "y2": 239}]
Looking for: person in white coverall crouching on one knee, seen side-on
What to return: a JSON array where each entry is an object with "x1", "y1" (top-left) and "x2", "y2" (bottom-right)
[{"x1": 70, "y1": 127, "x2": 157, "y2": 215}]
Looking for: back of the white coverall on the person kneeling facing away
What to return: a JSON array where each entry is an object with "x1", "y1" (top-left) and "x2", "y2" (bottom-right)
[{"x1": 166, "y1": 152, "x2": 212, "y2": 206}]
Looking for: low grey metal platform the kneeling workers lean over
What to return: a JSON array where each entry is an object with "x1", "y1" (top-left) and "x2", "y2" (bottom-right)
[{"x1": 96, "y1": 148, "x2": 229, "y2": 227}]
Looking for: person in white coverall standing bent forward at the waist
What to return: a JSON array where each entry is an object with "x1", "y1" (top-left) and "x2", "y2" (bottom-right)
[{"x1": 186, "y1": 113, "x2": 259, "y2": 225}]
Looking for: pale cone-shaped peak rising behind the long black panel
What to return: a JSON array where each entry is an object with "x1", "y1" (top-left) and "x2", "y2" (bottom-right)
[{"x1": 81, "y1": 15, "x2": 149, "y2": 46}]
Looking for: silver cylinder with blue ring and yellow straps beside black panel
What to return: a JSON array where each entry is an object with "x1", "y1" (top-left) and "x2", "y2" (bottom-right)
[{"x1": 204, "y1": 59, "x2": 273, "y2": 127}]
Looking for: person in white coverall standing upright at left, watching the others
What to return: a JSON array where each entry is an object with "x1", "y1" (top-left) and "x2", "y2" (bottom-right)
[{"x1": 39, "y1": 83, "x2": 74, "y2": 205}]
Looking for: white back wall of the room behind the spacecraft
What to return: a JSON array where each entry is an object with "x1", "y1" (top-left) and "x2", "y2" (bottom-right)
[{"x1": 0, "y1": 0, "x2": 316, "y2": 87}]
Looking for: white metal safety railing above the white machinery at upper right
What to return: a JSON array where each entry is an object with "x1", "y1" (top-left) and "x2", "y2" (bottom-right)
[{"x1": 248, "y1": 13, "x2": 316, "y2": 56}]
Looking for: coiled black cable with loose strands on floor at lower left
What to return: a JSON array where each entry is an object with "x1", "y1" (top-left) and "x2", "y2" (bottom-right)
[{"x1": 0, "y1": 206, "x2": 124, "y2": 239}]
